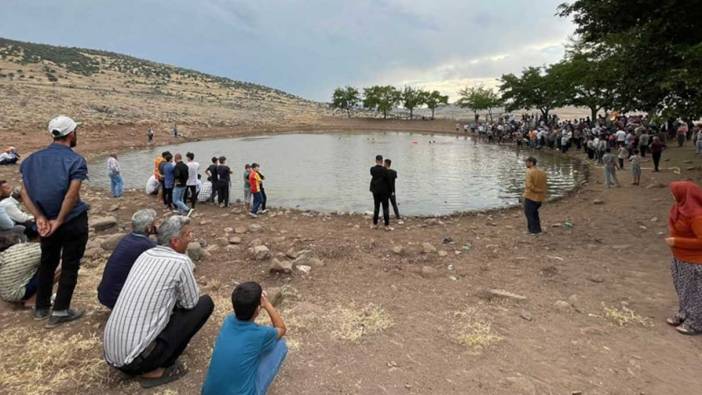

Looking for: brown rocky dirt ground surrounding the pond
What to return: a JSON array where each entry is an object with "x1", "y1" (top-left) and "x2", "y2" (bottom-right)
[{"x1": 0, "y1": 120, "x2": 702, "y2": 394}]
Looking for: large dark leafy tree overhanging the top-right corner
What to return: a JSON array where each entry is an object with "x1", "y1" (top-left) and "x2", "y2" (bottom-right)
[{"x1": 559, "y1": 0, "x2": 702, "y2": 118}]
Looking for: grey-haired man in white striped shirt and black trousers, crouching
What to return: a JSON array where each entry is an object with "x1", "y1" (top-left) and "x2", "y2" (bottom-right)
[{"x1": 103, "y1": 216, "x2": 214, "y2": 388}]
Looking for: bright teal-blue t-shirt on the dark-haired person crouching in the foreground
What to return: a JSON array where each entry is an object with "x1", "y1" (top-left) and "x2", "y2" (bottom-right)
[{"x1": 202, "y1": 314, "x2": 278, "y2": 395}]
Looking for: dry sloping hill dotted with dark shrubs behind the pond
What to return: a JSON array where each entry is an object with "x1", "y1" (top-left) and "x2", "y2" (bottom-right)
[{"x1": 0, "y1": 38, "x2": 330, "y2": 134}]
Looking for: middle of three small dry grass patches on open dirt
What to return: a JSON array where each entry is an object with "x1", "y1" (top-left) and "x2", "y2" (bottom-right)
[{"x1": 451, "y1": 307, "x2": 503, "y2": 351}]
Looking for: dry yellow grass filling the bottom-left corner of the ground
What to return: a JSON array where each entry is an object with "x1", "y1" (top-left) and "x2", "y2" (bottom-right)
[{"x1": 0, "y1": 327, "x2": 109, "y2": 394}]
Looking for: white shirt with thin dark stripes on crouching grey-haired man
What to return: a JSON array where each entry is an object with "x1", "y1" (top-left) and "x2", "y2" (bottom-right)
[{"x1": 103, "y1": 246, "x2": 200, "y2": 367}]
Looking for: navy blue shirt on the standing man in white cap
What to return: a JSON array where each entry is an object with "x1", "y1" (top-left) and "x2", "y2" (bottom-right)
[{"x1": 20, "y1": 143, "x2": 88, "y2": 222}]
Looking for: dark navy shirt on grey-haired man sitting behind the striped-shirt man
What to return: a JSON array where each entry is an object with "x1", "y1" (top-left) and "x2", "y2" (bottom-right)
[{"x1": 98, "y1": 233, "x2": 156, "y2": 309}]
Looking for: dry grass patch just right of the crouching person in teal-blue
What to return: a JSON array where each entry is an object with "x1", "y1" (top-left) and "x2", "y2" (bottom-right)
[{"x1": 329, "y1": 303, "x2": 393, "y2": 343}]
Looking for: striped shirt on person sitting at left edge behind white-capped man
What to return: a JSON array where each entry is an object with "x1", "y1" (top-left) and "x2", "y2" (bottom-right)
[{"x1": 0, "y1": 243, "x2": 41, "y2": 302}]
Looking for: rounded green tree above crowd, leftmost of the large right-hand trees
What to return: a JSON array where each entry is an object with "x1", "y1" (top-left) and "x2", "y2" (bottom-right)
[{"x1": 500, "y1": 67, "x2": 567, "y2": 118}]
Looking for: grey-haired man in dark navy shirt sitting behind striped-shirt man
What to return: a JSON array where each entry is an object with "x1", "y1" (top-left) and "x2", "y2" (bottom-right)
[{"x1": 98, "y1": 209, "x2": 158, "y2": 309}]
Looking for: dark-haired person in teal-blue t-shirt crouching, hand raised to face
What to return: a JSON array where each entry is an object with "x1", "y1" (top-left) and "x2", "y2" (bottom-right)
[{"x1": 202, "y1": 282, "x2": 288, "y2": 395}]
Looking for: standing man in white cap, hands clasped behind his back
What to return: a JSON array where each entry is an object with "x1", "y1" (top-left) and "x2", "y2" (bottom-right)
[{"x1": 20, "y1": 115, "x2": 88, "y2": 328}]
